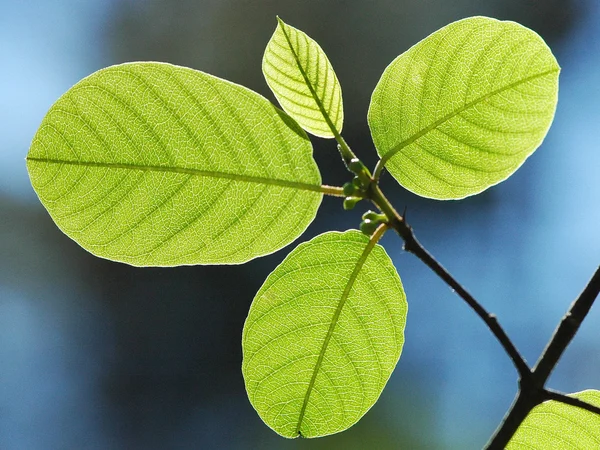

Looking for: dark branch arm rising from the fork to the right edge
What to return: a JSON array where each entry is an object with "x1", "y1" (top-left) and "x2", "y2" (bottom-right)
[{"x1": 533, "y1": 267, "x2": 600, "y2": 386}]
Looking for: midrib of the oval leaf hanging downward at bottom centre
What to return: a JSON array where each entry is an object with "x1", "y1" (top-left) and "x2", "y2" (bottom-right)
[{"x1": 296, "y1": 227, "x2": 386, "y2": 436}]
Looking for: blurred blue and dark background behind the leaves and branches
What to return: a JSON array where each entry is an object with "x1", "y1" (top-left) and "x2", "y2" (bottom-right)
[{"x1": 0, "y1": 0, "x2": 600, "y2": 450}]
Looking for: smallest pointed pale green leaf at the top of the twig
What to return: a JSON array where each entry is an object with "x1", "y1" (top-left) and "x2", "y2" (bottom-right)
[{"x1": 262, "y1": 18, "x2": 344, "y2": 138}]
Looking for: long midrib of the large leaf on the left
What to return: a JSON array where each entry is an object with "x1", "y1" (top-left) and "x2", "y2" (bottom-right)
[{"x1": 27, "y1": 156, "x2": 330, "y2": 193}]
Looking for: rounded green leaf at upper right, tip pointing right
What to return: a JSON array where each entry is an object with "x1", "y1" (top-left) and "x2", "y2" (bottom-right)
[{"x1": 368, "y1": 17, "x2": 560, "y2": 199}]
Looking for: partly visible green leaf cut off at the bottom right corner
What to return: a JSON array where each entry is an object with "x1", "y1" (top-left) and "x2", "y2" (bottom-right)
[{"x1": 506, "y1": 390, "x2": 600, "y2": 450}]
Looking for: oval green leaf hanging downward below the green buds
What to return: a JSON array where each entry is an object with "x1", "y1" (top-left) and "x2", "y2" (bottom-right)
[{"x1": 242, "y1": 231, "x2": 407, "y2": 438}]
